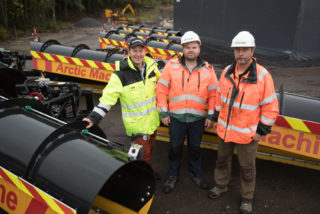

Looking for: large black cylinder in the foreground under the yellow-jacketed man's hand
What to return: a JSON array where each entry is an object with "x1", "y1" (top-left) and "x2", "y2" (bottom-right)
[{"x1": 0, "y1": 100, "x2": 155, "y2": 213}]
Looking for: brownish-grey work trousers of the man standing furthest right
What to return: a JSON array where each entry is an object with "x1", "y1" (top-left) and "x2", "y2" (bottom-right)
[{"x1": 214, "y1": 138, "x2": 258, "y2": 201}]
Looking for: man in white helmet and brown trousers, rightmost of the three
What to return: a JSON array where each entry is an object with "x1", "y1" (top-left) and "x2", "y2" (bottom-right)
[{"x1": 208, "y1": 31, "x2": 279, "y2": 213}]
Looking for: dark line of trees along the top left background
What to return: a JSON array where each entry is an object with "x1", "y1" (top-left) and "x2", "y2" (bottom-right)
[{"x1": 0, "y1": 0, "x2": 173, "y2": 39}]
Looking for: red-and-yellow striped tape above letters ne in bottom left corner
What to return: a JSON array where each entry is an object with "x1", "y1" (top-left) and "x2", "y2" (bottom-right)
[{"x1": 0, "y1": 167, "x2": 76, "y2": 214}]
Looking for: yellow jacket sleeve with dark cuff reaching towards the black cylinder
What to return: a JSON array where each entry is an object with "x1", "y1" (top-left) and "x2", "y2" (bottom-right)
[{"x1": 88, "y1": 73, "x2": 123, "y2": 124}]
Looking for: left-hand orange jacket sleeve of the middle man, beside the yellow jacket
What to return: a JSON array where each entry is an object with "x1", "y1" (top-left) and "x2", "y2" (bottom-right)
[{"x1": 156, "y1": 63, "x2": 171, "y2": 118}]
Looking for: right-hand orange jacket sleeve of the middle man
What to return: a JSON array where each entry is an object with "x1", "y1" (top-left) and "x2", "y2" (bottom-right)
[{"x1": 207, "y1": 68, "x2": 218, "y2": 120}]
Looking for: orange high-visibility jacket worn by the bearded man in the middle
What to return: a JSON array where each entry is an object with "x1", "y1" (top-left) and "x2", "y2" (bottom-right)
[{"x1": 156, "y1": 58, "x2": 217, "y2": 122}]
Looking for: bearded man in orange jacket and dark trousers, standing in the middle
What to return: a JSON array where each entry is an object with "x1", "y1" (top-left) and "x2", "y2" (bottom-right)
[{"x1": 156, "y1": 31, "x2": 217, "y2": 193}]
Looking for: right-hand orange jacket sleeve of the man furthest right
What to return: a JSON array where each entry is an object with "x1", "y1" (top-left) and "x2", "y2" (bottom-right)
[{"x1": 257, "y1": 72, "x2": 279, "y2": 135}]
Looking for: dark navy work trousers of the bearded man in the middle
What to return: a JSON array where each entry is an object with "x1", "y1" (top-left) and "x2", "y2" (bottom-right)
[{"x1": 168, "y1": 117, "x2": 205, "y2": 177}]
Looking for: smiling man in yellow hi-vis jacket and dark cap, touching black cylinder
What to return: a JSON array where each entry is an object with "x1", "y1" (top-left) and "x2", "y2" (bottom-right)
[{"x1": 83, "y1": 38, "x2": 160, "y2": 177}]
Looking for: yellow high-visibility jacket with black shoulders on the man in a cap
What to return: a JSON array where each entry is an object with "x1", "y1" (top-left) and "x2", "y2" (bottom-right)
[{"x1": 89, "y1": 56, "x2": 160, "y2": 136}]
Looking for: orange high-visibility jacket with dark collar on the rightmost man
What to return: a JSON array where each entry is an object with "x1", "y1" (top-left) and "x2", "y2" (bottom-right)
[{"x1": 215, "y1": 59, "x2": 279, "y2": 144}]
